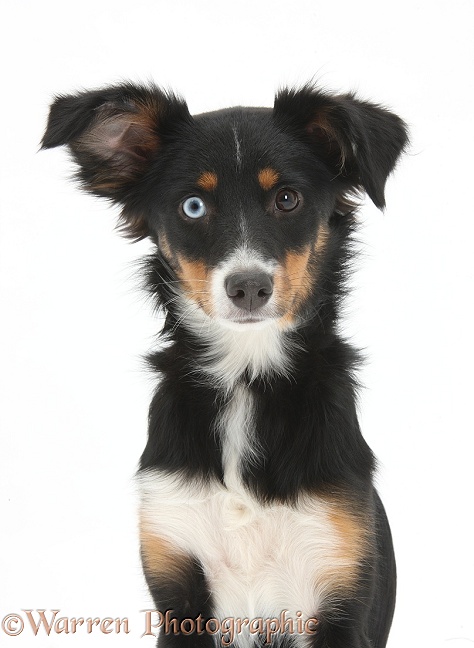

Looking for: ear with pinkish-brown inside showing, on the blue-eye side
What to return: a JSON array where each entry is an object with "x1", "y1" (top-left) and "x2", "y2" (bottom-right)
[{"x1": 42, "y1": 84, "x2": 191, "y2": 239}]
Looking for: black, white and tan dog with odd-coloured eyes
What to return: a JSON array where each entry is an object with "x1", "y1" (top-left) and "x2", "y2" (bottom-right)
[{"x1": 42, "y1": 83, "x2": 408, "y2": 648}]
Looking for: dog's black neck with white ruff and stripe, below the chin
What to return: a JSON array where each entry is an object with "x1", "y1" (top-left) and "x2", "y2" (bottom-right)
[{"x1": 141, "y1": 304, "x2": 373, "y2": 501}]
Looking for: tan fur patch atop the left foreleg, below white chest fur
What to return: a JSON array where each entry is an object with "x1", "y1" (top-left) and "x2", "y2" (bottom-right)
[{"x1": 140, "y1": 525, "x2": 190, "y2": 581}]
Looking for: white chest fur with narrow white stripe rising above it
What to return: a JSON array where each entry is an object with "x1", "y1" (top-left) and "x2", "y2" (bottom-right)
[{"x1": 140, "y1": 389, "x2": 353, "y2": 618}]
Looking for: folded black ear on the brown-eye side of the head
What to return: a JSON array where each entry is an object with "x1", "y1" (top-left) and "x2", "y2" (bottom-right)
[{"x1": 274, "y1": 86, "x2": 408, "y2": 209}]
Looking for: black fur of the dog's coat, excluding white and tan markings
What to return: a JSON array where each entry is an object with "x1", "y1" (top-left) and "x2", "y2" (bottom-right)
[{"x1": 43, "y1": 84, "x2": 407, "y2": 648}]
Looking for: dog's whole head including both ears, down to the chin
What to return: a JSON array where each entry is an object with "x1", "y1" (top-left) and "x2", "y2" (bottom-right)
[{"x1": 44, "y1": 86, "x2": 406, "y2": 329}]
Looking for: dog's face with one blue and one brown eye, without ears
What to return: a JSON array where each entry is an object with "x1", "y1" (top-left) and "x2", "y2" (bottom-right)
[{"x1": 149, "y1": 109, "x2": 334, "y2": 327}]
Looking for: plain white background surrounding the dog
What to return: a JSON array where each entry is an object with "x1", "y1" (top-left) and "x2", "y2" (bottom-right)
[{"x1": 0, "y1": 0, "x2": 474, "y2": 648}]
